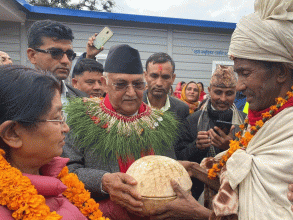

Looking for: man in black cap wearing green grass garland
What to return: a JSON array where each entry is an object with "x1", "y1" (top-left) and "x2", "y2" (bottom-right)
[{"x1": 63, "y1": 45, "x2": 177, "y2": 220}]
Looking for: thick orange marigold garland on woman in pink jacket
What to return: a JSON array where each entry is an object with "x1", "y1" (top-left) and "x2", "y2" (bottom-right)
[{"x1": 0, "y1": 149, "x2": 109, "y2": 220}]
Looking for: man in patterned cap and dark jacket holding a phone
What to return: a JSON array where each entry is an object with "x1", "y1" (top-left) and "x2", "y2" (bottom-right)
[{"x1": 175, "y1": 66, "x2": 246, "y2": 203}]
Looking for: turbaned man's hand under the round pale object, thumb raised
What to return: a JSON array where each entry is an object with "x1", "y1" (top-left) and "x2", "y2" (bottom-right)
[{"x1": 151, "y1": 180, "x2": 211, "y2": 220}]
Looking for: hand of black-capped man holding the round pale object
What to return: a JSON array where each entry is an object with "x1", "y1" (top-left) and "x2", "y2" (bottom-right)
[{"x1": 102, "y1": 173, "x2": 143, "y2": 216}]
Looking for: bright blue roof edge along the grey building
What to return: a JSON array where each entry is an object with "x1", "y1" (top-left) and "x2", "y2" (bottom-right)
[{"x1": 15, "y1": 0, "x2": 236, "y2": 29}]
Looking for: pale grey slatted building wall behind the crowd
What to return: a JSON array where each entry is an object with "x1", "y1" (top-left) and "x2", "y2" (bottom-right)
[{"x1": 0, "y1": 20, "x2": 231, "y2": 91}]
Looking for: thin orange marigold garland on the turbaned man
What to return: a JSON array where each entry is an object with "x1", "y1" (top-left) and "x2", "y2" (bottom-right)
[{"x1": 208, "y1": 86, "x2": 293, "y2": 179}]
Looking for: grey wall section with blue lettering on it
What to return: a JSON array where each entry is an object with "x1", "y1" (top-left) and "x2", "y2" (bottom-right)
[{"x1": 173, "y1": 31, "x2": 231, "y2": 88}]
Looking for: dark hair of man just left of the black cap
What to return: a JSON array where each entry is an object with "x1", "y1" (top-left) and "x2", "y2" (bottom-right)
[{"x1": 72, "y1": 58, "x2": 104, "y2": 78}]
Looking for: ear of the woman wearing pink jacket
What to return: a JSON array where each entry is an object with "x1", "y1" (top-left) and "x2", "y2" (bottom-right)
[{"x1": 0, "y1": 121, "x2": 23, "y2": 148}]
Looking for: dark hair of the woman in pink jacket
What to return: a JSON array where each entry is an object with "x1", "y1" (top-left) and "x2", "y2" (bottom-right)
[{"x1": 0, "y1": 65, "x2": 61, "y2": 127}]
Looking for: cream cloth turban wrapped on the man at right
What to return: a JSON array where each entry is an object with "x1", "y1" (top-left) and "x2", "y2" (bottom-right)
[{"x1": 228, "y1": 0, "x2": 293, "y2": 64}]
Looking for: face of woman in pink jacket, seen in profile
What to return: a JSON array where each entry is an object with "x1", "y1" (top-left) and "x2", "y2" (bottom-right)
[{"x1": 18, "y1": 90, "x2": 69, "y2": 165}]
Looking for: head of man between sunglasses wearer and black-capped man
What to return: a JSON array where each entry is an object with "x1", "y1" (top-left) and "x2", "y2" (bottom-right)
[{"x1": 72, "y1": 58, "x2": 105, "y2": 97}]
